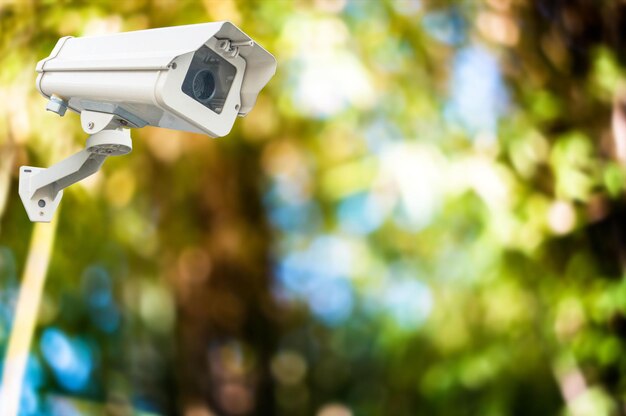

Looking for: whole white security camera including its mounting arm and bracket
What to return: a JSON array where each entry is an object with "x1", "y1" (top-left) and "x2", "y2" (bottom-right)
[{"x1": 19, "y1": 22, "x2": 276, "y2": 222}]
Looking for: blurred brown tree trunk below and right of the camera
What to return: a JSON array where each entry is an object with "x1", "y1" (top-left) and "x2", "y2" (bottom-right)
[{"x1": 149, "y1": 137, "x2": 276, "y2": 415}]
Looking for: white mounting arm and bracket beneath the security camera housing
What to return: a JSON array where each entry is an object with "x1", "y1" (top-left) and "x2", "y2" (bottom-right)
[{"x1": 19, "y1": 109, "x2": 137, "y2": 222}]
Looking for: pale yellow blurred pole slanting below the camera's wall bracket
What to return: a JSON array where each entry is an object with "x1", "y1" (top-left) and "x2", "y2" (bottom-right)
[{"x1": 0, "y1": 220, "x2": 57, "y2": 416}]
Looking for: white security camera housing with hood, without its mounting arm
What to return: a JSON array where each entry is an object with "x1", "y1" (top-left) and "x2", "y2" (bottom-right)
[{"x1": 37, "y1": 22, "x2": 276, "y2": 137}]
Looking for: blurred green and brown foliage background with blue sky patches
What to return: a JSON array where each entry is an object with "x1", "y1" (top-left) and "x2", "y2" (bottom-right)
[{"x1": 0, "y1": 0, "x2": 626, "y2": 416}]
